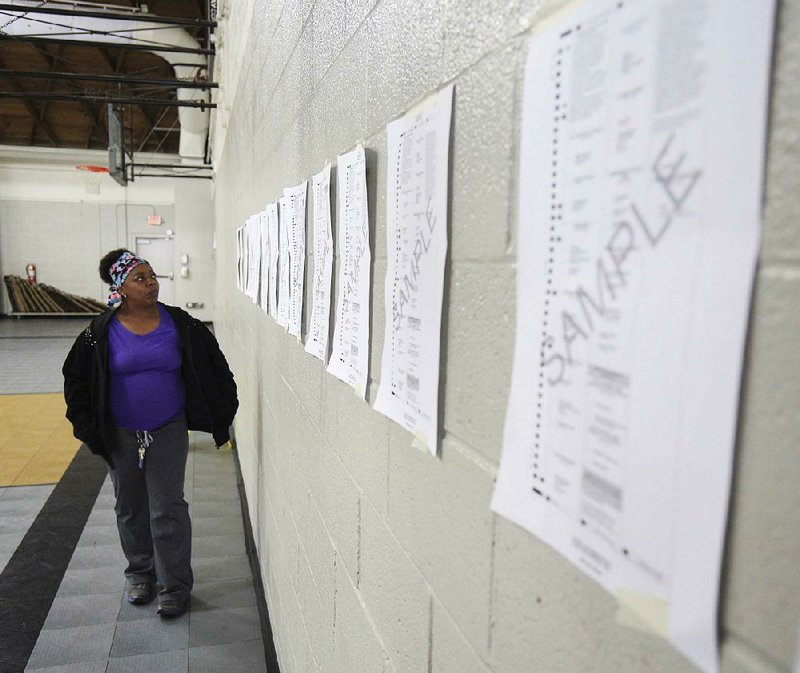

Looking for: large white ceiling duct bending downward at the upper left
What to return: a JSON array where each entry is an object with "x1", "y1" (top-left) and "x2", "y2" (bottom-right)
[{"x1": 0, "y1": 0, "x2": 211, "y2": 163}]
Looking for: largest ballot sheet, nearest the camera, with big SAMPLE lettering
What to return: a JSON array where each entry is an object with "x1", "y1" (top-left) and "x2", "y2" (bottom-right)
[{"x1": 492, "y1": 0, "x2": 773, "y2": 672}]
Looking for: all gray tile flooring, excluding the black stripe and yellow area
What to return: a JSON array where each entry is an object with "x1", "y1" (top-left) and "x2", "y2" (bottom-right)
[{"x1": 0, "y1": 319, "x2": 267, "y2": 673}]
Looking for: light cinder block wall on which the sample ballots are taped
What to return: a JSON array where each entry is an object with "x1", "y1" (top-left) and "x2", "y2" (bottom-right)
[{"x1": 209, "y1": 0, "x2": 800, "y2": 673}]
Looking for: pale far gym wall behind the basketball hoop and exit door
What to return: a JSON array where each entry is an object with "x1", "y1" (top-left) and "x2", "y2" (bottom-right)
[{"x1": 0, "y1": 148, "x2": 216, "y2": 321}]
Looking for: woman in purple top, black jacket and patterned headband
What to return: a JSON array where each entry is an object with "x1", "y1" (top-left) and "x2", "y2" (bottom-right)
[{"x1": 63, "y1": 249, "x2": 239, "y2": 617}]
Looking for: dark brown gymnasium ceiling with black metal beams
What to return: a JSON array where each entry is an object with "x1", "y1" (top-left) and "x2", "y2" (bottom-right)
[{"x1": 0, "y1": 0, "x2": 216, "y2": 154}]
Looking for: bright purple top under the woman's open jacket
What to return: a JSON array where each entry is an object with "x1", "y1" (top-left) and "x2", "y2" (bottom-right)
[{"x1": 108, "y1": 304, "x2": 186, "y2": 430}]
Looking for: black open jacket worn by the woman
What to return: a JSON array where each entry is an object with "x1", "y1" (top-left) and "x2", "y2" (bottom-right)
[{"x1": 62, "y1": 304, "x2": 239, "y2": 462}]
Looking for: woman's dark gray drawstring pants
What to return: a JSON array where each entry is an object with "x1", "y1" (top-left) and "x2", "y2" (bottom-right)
[{"x1": 109, "y1": 416, "x2": 194, "y2": 599}]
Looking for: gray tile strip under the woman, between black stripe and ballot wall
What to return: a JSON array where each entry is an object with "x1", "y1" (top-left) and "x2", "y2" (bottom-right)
[{"x1": 25, "y1": 433, "x2": 267, "y2": 673}]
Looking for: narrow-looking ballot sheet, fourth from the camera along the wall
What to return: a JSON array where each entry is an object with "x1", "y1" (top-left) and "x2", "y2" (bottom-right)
[{"x1": 306, "y1": 164, "x2": 333, "y2": 362}]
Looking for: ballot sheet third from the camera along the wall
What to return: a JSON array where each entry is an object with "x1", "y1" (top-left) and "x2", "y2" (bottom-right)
[{"x1": 328, "y1": 147, "x2": 370, "y2": 399}]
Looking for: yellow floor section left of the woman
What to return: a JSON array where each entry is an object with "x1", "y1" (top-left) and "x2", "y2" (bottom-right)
[{"x1": 0, "y1": 393, "x2": 81, "y2": 486}]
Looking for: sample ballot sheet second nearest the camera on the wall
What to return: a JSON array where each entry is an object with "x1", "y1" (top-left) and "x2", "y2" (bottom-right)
[{"x1": 375, "y1": 85, "x2": 453, "y2": 455}]
